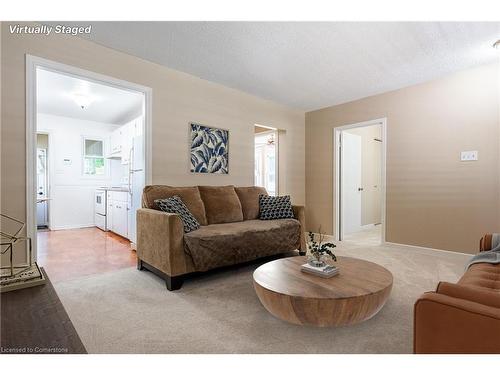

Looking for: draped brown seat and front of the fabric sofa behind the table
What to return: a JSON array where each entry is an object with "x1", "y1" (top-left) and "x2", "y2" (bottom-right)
[{"x1": 184, "y1": 219, "x2": 301, "y2": 271}]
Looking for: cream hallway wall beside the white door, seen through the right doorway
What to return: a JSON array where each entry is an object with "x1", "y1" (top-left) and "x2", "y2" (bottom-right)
[{"x1": 346, "y1": 125, "x2": 382, "y2": 225}]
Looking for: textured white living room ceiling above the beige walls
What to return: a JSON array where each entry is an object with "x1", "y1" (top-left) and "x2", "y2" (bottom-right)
[{"x1": 63, "y1": 22, "x2": 500, "y2": 110}]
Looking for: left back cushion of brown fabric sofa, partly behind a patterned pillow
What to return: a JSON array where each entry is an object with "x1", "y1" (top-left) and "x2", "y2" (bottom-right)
[{"x1": 142, "y1": 185, "x2": 208, "y2": 225}]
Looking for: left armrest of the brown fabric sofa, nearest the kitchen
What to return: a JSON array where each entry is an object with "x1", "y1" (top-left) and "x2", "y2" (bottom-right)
[{"x1": 137, "y1": 208, "x2": 192, "y2": 276}]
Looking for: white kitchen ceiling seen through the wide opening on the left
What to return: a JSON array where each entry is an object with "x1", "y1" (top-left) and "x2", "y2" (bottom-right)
[{"x1": 37, "y1": 69, "x2": 143, "y2": 124}]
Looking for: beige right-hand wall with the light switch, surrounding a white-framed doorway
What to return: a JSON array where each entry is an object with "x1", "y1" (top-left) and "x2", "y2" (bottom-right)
[{"x1": 306, "y1": 64, "x2": 500, "y2": 253}]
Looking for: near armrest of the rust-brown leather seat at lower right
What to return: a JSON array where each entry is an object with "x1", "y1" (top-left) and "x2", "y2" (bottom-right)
[{"x1": 413, "y1": 292, "x2": 500, "y2": 353}]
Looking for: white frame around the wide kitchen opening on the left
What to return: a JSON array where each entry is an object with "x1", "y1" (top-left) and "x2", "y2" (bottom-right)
[{"x1": 26, "y1": 54, "x2": 153, "y2": 261}]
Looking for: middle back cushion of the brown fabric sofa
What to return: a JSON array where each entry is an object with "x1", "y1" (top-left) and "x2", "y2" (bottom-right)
[{"x1": 199, "y1": 185, "x2": 243, "y2": 224}]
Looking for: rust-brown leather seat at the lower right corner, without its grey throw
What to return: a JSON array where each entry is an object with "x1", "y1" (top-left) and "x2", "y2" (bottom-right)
[{"x1": 413, "y1": 235, "x2": 500, "y2": 354}]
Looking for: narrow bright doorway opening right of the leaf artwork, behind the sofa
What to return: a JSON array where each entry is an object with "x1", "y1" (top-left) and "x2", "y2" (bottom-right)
[{"x1": 254, "y1": 125, "x2": 279, "y2": 196}]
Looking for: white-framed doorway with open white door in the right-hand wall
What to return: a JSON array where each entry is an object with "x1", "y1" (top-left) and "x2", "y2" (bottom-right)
[{"x1": 334, "y1": 118, "x2": 387, "y2": 245}]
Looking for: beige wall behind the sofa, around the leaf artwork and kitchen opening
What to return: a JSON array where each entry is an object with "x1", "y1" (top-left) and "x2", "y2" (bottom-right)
[{"x1": 1, "y1": 22, "x2": 305, "y2": 218}]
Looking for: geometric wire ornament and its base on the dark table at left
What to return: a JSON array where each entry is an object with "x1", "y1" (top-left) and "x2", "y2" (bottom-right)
[{"x1": 0, "y1": 214, "x2": 45, "y2": 292}]
